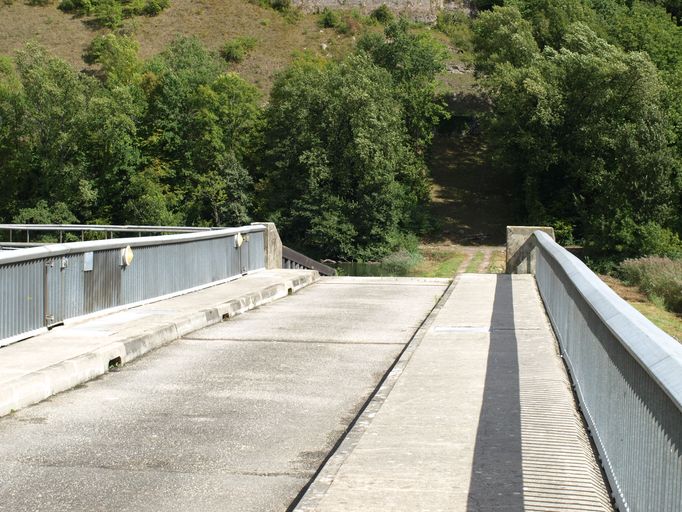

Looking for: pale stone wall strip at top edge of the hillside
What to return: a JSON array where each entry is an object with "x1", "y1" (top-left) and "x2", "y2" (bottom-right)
[{"x1": 293, "y1": 0, "x2": 468, "y2": 21}]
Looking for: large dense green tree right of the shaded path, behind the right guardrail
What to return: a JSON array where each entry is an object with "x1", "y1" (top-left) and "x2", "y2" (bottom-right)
[{"x1": 478, "y1": 20, "x2": 681, "y2": 259}]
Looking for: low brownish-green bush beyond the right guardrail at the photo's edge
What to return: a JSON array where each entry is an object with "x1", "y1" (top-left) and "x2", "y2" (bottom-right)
[{"x1": 618, "y1": 258, "x2": 682, "y2": 313}]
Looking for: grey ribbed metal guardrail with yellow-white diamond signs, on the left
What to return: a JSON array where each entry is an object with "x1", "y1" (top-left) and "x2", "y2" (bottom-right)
[{"x1": 0, "y1": 225, "x2": 265, "y2": 346}]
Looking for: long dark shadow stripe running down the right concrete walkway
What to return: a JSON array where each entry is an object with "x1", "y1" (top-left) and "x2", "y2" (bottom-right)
[{"x1": 467, "y1": 274, "x2": 523, "y2": 512}]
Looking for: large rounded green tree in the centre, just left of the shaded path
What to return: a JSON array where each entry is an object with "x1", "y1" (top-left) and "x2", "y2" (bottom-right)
[{"x1": 255, "y1": 53, "x2": 428, "y2": 260}]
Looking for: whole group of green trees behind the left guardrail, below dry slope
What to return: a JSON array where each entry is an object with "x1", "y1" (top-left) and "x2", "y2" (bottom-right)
[{"x1": 0, "y1": 40, "x2": 261, "y2": 230}]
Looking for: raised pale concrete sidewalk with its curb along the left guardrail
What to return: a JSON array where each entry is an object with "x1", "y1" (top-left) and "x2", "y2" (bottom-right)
[{"x1": 0, "y1": 270, "x2": 319, "y2": 416}]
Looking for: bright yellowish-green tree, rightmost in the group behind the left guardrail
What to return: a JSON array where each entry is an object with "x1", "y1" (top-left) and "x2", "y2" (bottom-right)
[{"x1": 143, "y1": 38, "x2": 260, "y2": 225}]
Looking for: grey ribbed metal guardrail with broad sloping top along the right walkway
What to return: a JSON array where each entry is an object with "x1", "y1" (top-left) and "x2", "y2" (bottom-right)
[{"x1": 525, "y1": 231, "x2": 682, "y2": 512}]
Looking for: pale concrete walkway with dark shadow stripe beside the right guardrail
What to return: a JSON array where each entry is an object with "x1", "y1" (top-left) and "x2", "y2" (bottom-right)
[{"x1": 296, "y1": 274, "x2": 612, "y2": 512}]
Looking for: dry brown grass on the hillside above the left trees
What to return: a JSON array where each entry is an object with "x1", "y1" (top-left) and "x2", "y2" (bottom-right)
[{"x1": 0, "y1": 0, "x2": 362, "y2": 93}]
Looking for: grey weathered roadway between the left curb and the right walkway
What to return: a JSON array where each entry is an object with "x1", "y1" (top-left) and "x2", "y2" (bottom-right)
[{"x1": 0, "y1": 278, "x2": 447, "y2": 512}]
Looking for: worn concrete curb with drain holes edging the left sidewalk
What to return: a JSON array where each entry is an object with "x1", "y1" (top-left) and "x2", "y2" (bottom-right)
[{"x1": 0, "y1": 272, "x2": 319, "y2": 417}]
